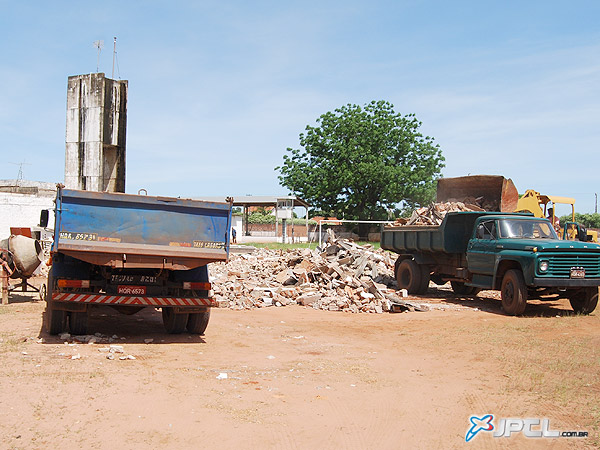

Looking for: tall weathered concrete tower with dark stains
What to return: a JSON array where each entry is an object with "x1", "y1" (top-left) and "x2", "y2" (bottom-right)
[{"x1": 65, "y1": 73, "x2": 128, "y2": 192}]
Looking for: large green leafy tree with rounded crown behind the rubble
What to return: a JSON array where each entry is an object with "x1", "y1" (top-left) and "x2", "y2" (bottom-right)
[{"x1": 275, "y1": 101, "x2": 444, "y2": 220}]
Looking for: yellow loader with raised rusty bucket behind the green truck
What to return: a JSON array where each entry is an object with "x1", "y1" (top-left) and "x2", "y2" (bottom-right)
[{"x1": 436, "y1": 175, "x2": 598, "y2": 242}]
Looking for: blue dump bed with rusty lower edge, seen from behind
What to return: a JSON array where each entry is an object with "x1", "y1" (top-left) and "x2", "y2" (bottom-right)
[{"x1": 52, "y1": 189, "x2": 231, "y2": 270}]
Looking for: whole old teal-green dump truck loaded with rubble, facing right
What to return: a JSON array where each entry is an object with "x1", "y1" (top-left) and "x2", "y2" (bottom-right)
[{"x1": 381, "y1": 212, "x2": 600, "y2": 315}]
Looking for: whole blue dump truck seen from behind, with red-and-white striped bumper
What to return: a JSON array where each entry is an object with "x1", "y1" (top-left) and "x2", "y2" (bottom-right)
[{"x1": 42, "y1": 186, "x2": 232, "y2": 334}]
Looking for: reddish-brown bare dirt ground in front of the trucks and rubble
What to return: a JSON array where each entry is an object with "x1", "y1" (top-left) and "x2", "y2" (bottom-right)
[{"x1": 0, "y1": 280, "x2": 600, "y2": 449}]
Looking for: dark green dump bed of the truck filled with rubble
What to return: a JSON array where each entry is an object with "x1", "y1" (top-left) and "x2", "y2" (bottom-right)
[{"x1": 381, "y1": 212, "x2": 498, "y2": 254}]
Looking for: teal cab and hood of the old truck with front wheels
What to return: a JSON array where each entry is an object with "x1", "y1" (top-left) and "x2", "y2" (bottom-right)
[{"x1": 466, "y1": 215, "x2": 600, "y2": 314}]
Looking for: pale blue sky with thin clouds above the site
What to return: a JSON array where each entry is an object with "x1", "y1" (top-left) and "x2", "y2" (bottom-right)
[{"x1": 0, "y1": 0, "x2": 600, "y2": 214}]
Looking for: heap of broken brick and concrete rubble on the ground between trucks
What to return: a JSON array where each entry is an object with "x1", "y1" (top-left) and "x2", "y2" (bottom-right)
[{"x1": 210, "y1": 230, "x2": 425, "y2": 313}]
